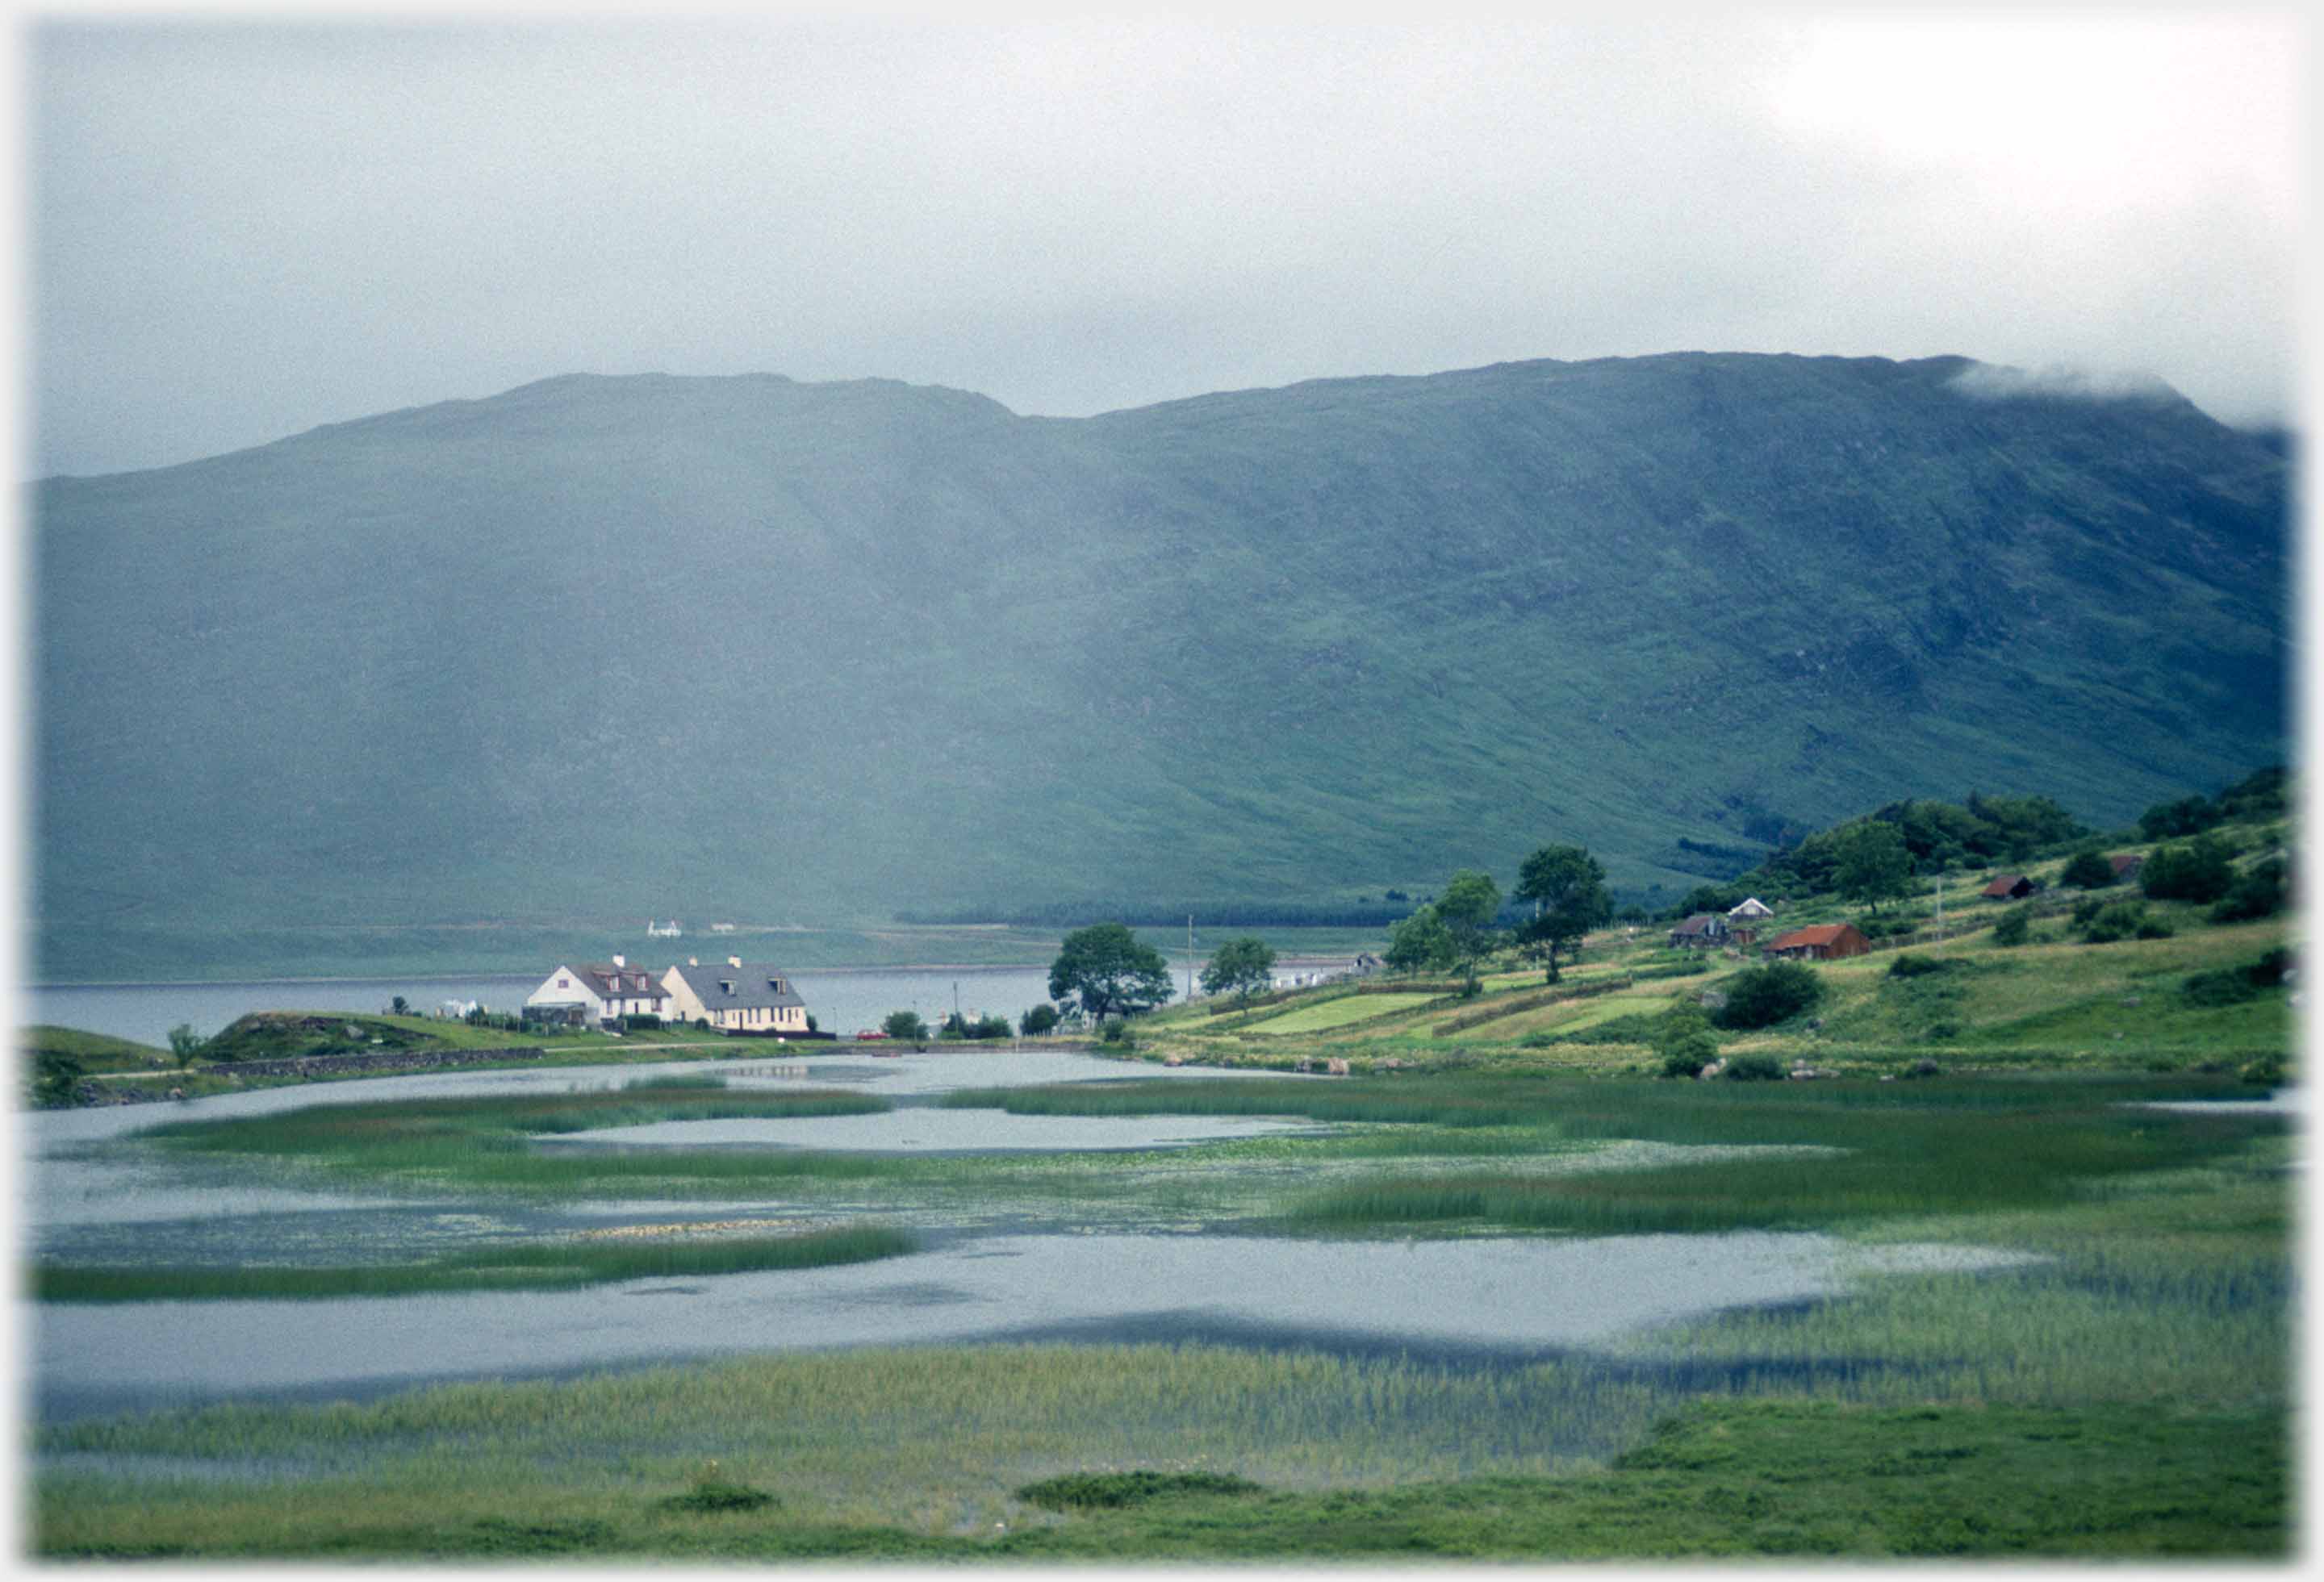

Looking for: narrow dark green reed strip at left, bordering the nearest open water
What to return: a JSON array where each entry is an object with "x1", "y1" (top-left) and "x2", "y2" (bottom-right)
[{"x1": 30, "y1": 1226, "x2": 918, "y2": 1301}]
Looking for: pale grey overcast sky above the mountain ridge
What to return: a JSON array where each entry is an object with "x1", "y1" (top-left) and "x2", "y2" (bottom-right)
[{"x1": 23, "y1": 7, "x2": 2310, "y2": 476}]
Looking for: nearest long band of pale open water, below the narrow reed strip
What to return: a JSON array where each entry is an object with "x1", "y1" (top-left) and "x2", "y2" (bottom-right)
[{"x1": 32, "y1": 1233, "x2": 2029, "y2": 1417}]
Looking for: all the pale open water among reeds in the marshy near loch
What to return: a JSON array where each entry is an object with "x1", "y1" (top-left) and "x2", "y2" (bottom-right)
[{"x1": 31, "y1": 1050, "x2": 2020, "y2": 1421}]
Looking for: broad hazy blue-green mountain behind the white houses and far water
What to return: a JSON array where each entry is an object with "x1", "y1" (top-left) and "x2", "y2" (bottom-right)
[{"x1": 30, "y1": 353, "x2": 2289, "y2": 975}]
